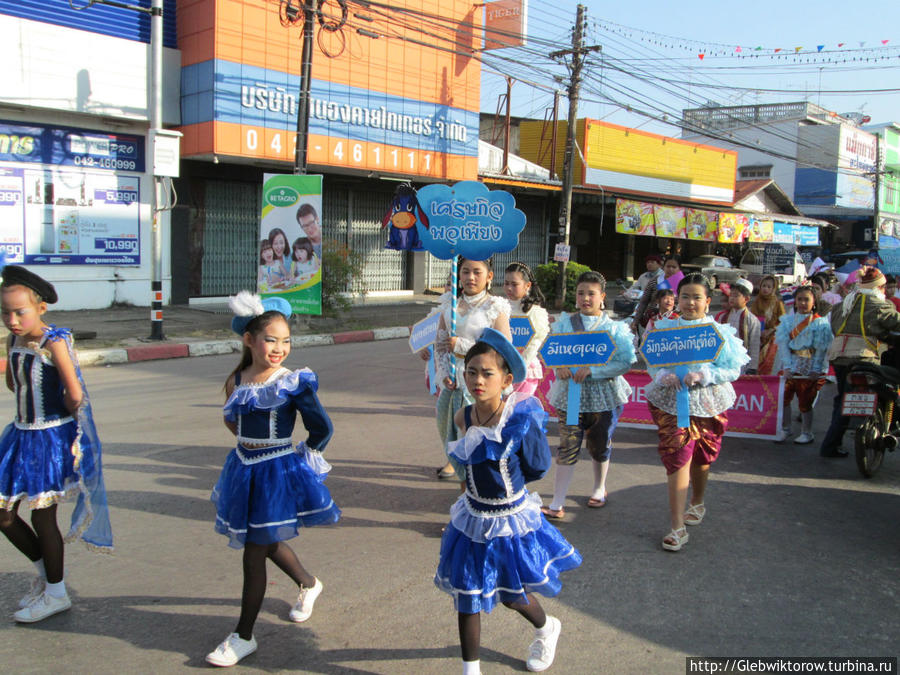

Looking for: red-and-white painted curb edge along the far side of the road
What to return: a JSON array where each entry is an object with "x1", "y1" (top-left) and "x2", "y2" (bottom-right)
[{"x1": 0, "y1": 326, "x2": 409, "y2": 373}]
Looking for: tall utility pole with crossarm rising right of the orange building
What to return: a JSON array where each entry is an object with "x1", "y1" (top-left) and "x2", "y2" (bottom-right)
[{"x1": 550, "y1": 5, "x2": 599, "y2": 309}]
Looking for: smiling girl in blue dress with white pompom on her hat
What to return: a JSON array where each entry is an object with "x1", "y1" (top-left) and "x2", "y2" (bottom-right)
[{"x1": 206, "y1": 291, "x2": 341, "y2": 666}]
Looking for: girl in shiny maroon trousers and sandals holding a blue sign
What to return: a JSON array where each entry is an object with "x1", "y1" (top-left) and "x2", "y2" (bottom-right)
[{"x1": 644, "y1": 274, "x2": 750, "y2": 551}]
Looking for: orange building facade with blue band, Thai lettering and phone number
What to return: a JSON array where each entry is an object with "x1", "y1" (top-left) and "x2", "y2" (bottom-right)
[{"x1": 177, "y1": 0, "x2": 482, "y2": 180}]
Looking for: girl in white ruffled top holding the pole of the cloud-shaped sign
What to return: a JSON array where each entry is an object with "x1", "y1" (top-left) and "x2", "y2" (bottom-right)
[{"x1": 435, "y1": 258, "x2": 511, "y2": 480}]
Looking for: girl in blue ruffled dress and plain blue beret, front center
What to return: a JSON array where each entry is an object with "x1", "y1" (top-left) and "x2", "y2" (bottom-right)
[{"x1": 434, "y1": 328, "x2": 581, "y2": 675}]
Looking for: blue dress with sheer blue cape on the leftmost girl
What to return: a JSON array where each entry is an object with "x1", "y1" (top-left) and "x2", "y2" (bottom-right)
[{"x1": 0, "y1": 325, "x2": 113, "y2": 551}]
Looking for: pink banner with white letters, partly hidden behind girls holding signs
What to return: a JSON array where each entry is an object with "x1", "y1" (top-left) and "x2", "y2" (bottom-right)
[{"x1": 535, "y1": 370, "x2": 784, "y2": 439}]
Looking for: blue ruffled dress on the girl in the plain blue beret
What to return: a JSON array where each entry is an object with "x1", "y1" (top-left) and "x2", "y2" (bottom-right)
[{"x1": 434, "y1": 393, "x2": 581, "y2": 614}]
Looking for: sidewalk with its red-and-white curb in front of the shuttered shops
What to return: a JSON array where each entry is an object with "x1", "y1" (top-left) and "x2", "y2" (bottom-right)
[{"x1": 0, "y1": 295, "x2": 438, "y2": 371}]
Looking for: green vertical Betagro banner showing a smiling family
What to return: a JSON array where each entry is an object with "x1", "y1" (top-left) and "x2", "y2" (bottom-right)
[{"x1": 256, "y1": 173, "x2": 322, "y2": 314}]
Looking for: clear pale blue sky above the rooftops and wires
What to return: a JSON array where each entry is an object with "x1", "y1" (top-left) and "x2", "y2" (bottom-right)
[{"x1": 482, "y1": 0, "x2": 900, "y2": 136}]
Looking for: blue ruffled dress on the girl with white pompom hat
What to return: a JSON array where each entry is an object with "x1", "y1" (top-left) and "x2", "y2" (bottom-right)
[{"x1": 211, "y1": 368, "x2": 341, "y2": 548}]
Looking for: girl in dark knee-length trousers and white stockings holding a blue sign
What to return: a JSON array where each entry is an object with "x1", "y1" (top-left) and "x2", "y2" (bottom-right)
[{"x1": 541, "y1": 272, "x2": 637, "y2": 519}]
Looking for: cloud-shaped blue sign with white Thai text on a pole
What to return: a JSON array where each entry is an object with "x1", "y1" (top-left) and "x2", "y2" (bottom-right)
[{"x1": 416, "y1": 180, "x2": 525, "y2": 260}]
